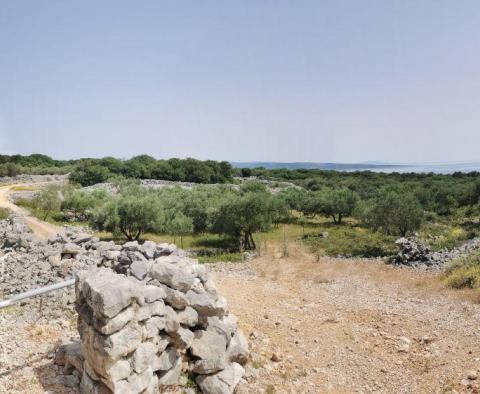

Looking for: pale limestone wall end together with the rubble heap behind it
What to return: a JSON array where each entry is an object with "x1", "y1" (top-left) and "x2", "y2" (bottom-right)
[{"x1": 0, "y1": 217, "x2": 248, "y2": 394}]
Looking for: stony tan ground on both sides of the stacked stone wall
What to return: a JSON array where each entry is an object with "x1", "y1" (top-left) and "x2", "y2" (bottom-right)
[{"x1": 0, "y1": 182, "x2": 480, "y2": 394}]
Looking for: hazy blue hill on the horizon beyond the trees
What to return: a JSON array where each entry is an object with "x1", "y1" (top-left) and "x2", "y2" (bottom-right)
[{"x1": 230, "y1": 161, "x2": 409, "y2": 171}]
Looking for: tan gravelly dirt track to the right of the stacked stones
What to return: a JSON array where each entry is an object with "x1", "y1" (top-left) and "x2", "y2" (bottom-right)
[{"x1": 216, "y1": 245, "x2": 480, "y2": 393}]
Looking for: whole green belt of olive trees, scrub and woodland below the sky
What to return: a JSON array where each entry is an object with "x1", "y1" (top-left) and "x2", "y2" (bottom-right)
[{"x1": 6, "y1": 155, "x2": 480, "y2": 287}]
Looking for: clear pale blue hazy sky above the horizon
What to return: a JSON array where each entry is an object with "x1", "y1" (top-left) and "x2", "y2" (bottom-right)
[{"x1": 0, "y1": 0, "x2": 480, "y2": 163}]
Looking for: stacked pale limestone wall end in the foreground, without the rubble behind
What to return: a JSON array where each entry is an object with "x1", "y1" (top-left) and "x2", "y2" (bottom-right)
[{"x1": 59, "y1": 242, "x2": 248, "y2": 393}]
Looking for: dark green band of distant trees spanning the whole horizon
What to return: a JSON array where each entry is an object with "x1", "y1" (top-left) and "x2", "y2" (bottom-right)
[{"x1": 0, "y1": 154, "x2": 480, "y2": 215}]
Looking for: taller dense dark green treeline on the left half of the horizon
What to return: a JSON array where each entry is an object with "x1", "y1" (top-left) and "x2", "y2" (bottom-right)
[{"x1": 0, "y1": 154, "x2": 233, "y2": 186}]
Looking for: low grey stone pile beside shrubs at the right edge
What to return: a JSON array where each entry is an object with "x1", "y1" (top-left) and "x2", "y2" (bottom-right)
[{"x1": 392, "y1": 238, "x2": 480, "y2": 269}]
